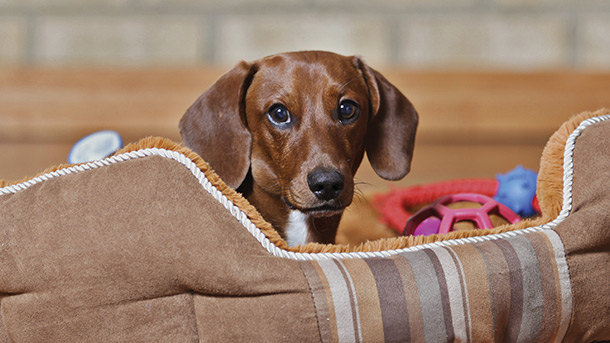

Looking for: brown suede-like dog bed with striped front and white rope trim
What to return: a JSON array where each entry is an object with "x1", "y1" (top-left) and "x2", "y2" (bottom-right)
[{"x1": 0, "y1": 110, "x2": 610, "y2": 342}]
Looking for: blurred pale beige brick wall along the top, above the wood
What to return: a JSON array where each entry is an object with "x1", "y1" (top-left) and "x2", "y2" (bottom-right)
[{"x1": 0, "y1": 0, "x2": 610, "y2": 71}]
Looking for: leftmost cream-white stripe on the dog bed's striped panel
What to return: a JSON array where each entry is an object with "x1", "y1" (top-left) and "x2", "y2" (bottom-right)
[{"x1": 318, "y1": 260, "x2": 356, "y2": 343}]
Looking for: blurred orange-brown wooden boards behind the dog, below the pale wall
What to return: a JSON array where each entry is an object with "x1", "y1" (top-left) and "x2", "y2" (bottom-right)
[{"x1": 0, "y1": 68, "x2": 610, "y2": 193}]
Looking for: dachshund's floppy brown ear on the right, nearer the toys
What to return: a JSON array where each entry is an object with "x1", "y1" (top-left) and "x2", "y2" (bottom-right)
[{"x1": 356, "y1": 57, "x2": 418, "y2": 180}]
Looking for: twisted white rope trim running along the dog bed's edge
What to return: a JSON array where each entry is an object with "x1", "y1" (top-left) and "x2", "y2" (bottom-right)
[{"x1": 0, "y1": 115, "x2": 610, "y2": 260}]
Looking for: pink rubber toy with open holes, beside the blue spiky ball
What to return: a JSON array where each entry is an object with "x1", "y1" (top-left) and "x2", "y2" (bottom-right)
[{"x1": 402, "y1": 193, "x2": 521, "y2": 236}]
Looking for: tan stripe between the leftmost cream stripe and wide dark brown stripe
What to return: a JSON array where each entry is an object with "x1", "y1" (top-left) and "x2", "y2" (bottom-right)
[{"x1": 342, "y1": 258, "x2": 383, "y2": 342}]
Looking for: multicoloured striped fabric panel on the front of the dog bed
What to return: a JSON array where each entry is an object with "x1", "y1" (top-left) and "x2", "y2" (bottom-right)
[{"x1": 300, "y1": 230, "x2": 572, "y2": 342}]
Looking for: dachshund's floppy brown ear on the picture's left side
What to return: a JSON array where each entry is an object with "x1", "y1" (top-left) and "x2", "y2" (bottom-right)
[{"x1": 180, "y1": 62, "x2": 256, "y2": 188}]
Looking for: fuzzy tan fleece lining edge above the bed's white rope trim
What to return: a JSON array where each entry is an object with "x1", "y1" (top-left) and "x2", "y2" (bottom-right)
[{"x1": 0, "y1": 109, "x2": 610, "y2": 253}]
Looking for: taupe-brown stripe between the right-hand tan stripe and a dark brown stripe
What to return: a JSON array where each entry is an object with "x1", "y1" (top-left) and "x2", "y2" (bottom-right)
[{"x1": 476, "y1": 242, "x2": 511, "y2": 342}]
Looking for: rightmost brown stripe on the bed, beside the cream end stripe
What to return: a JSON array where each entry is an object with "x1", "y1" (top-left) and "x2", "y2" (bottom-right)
[{"x1": 528, "y1": 234, "x2": 561, "y2": 342}]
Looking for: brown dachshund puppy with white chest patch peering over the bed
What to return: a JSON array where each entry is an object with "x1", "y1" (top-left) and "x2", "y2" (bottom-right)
[{"x1": 180, "y1": 51, "x2": 418, "y2": 246}]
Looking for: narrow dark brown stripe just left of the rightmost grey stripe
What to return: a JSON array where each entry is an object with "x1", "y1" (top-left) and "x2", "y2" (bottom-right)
[{"x1": 493, "y1": 239, "x2": 523, "y2": 342}]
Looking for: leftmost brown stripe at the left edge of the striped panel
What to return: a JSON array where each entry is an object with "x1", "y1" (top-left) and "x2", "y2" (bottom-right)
[{"x1": 300, "y1": 261, "x2": 333, "y2": 343}]
